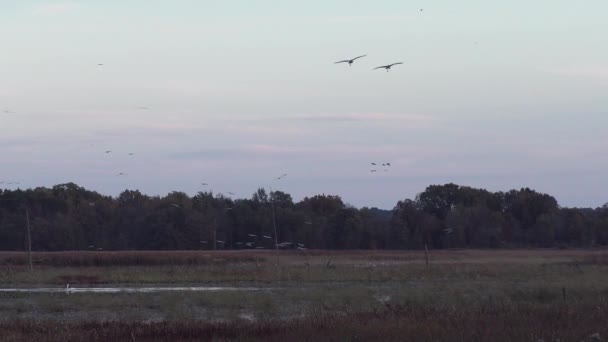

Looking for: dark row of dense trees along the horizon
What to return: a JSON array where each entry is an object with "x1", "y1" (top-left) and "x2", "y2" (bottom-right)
[{"x1": 0, "y1": 183, "x2": 608, "y2": 251}]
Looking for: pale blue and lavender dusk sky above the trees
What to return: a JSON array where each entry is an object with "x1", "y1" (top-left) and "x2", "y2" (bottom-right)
[{"x1": 0, "y1": 0, "x2": 608, "y2": 209}]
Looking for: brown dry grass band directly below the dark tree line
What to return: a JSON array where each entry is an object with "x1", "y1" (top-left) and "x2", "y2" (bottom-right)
[{"x1": 0, "y1": 249, "x2": 608, "y2": 267}]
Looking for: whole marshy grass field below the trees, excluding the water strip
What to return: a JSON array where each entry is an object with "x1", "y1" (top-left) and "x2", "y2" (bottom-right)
[{"x1": 0, "y1": 250, "x2": 608, "y2": 341}]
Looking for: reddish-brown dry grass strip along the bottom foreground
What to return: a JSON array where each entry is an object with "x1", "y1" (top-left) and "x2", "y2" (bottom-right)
[{"x1": 0, "y1": 303, "x2": 608, "y2": 341}]
